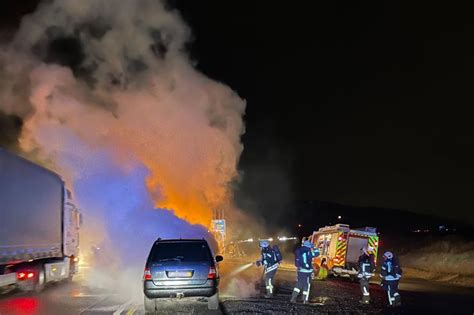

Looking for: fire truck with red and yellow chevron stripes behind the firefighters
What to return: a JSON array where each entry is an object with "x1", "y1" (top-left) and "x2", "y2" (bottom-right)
[{"x1": 309, "y1": 224, "x2": 379, "y2": 278}]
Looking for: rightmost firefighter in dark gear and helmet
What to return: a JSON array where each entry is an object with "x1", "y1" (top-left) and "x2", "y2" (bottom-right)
[{"x1": 380, "y1": 252, "x2": 402, "y2": 306}]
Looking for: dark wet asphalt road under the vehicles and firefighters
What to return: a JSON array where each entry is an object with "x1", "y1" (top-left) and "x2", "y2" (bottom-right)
[{"x1": 0, "y1": 261, "x2": 474, "y2": 315}]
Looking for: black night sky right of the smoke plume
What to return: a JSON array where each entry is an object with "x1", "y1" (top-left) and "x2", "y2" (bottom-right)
[{"x1": 0, "y1": 0, "x2": 474, "y2": 224}]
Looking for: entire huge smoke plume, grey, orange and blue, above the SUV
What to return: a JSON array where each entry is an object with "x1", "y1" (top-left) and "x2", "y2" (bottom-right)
[{"x1": 0, "y1": 0, "x2": 245, "y2": 298}]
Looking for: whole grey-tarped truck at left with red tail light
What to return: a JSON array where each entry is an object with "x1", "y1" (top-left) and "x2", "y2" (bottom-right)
[{"x1": 0, "y1": 148, "x2": 82, "y2": 291}]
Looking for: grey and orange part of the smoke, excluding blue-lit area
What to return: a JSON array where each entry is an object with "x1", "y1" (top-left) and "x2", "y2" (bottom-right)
[{"x1": 0, "y1": 0, "x2": 245, "y2": 223}]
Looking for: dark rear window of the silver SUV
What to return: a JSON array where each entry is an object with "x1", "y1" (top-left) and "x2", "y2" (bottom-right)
[{"x1": 150, "y1": 242, "x2": 211, "y2": 262}]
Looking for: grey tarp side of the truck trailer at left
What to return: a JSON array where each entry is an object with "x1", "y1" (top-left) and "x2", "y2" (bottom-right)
[{"x1": 0, "y1": 149, "x2": 63, "y2": 263}]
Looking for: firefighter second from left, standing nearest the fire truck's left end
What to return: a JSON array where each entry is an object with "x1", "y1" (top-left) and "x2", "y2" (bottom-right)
[{"x1": 291, "y1": 240, "x2": 319, "y2": 304}]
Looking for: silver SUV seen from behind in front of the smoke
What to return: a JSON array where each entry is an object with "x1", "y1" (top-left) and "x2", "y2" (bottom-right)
[{"x1": 143, "y1": 239, "x2": 223, "y2": 314}]
